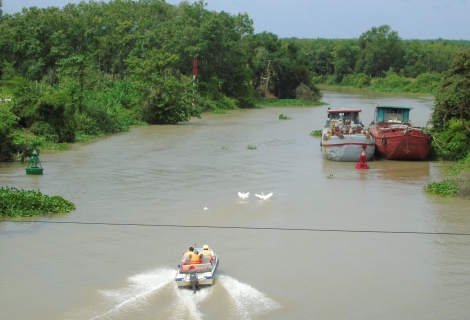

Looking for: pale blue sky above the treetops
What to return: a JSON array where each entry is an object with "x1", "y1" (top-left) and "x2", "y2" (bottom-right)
[{"x1": 3, "y1": 0, "x2": 470, "y2": 40}]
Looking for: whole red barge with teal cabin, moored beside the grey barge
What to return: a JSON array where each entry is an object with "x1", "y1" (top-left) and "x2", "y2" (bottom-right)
[{"x1": 369, "y1": 106, "x2": 432, "y2": 160}]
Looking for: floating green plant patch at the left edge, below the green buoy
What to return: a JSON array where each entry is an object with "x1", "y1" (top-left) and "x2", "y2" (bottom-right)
[{"x1": 0, "y1": 187, "x2": 75, "y2": 217}]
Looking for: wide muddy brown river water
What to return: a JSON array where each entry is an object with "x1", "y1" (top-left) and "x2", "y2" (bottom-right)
[{"x1": 0, "y1": 88, "x2": 470, "y2": 320}]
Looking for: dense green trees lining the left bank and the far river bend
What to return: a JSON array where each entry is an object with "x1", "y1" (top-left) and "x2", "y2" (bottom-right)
[{"x1": 0, "y1": 0, "x2": 469, "y2": 160}]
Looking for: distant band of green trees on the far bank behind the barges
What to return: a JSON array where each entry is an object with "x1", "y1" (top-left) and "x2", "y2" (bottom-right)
[{"x1": 292, "y1": 25, "x2": 470, "y2": 86}]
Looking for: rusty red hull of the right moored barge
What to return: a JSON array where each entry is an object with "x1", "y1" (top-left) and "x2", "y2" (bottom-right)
[{"x1": 370, "y1": 126, "x2": 431, "y2": 160}]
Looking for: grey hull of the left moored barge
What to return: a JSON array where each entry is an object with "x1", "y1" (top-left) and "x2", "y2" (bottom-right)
[{"x1": 322, "y1": 129, "x2": 375, "y2": 162}]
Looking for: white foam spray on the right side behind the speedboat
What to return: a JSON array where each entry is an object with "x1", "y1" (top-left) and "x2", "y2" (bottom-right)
[{"x1": 218, "y1": 275, "x2": 281, "y2": 319}]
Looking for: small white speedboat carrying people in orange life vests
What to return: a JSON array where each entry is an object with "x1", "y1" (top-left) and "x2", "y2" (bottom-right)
[{"x1": 175, "y1": 248, "x2": 219, "y2": 291}]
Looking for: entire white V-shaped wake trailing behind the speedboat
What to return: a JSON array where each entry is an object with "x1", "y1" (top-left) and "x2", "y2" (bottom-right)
[{"x1": 65, "y1": 269, "x2": 280, "y2": 320}]
